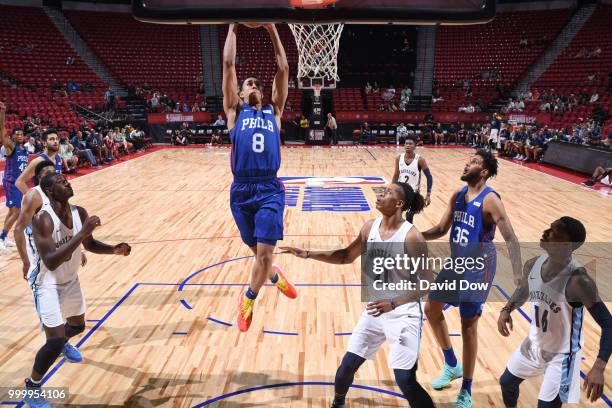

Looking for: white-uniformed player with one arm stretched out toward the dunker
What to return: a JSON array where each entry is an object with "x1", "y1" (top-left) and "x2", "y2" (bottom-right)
[{"x1": 282, "y1": 182, "x2": 434, "y2": 408}]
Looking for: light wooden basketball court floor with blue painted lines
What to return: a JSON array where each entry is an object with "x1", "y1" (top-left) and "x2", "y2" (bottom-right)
[{"x1": 0, "y1": 148, "x2": 612, "y2": 408}]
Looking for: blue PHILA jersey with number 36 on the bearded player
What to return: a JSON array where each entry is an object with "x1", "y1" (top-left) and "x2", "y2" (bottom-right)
[{"x1": 450, "y1": 186, "x2": 499, "y2": 260}]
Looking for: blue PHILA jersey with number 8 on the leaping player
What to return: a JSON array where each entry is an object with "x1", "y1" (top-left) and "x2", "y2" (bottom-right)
[{"x1": 230, "y1": 103, "x2": 280, "y2": 183}]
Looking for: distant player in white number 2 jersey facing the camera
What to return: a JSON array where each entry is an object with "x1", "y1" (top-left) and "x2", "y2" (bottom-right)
[{"x1": 392, "y1": 135, "x2": 433, "y2": 222}]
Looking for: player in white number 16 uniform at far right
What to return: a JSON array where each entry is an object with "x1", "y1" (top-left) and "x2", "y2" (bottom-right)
[{"x1": 498, "y1": 217, "x2": 612, "y2": 408}]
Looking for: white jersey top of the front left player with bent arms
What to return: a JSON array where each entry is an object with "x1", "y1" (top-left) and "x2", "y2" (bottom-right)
[{"x1": 29, "y1": 205, "x2": 83, "y2": 285}]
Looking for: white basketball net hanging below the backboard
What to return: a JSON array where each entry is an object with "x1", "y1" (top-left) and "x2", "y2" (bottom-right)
[{"x1": 289, "y1": 24, "x2": 344, "y2": 86}]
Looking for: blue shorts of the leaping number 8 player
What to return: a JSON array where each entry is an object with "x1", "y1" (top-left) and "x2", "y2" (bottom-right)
[{"x1": 230, "y1": 178, "x2": 285, "y2": 247}]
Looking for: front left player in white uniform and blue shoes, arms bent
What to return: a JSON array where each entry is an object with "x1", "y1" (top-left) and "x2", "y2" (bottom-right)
[{"x1": 25, "y1": 173, "x2": 131, "y2": 407}]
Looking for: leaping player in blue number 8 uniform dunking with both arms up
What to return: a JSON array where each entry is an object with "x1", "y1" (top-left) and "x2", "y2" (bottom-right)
[{"x1": 223, "y1": 24, "x2": 297, "y2": 331}]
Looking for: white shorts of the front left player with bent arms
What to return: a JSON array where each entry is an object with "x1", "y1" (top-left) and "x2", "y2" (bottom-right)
[{"x1": 32, "y1": 278, "x2": 86, "y2": 327}]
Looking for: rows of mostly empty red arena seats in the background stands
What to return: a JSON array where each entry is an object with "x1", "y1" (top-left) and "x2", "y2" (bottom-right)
[{"x1": 0, "y1": 5, "x2": 612, "y2": 132}]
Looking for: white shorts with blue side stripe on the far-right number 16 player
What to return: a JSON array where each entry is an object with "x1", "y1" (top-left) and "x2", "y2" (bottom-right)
[{"x1": 508, "y1": 339, "x2": 582, "y2": 404}]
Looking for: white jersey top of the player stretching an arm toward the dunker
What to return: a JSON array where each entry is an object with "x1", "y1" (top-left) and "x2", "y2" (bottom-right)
[{"x1": 363, "y1": 216, "x2": 421, "y2": 316}]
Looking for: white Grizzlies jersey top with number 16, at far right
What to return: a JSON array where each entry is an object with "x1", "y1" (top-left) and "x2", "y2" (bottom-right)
[{"x1": 528, "y1": 255, "x2": 584, "y2": 354}]
